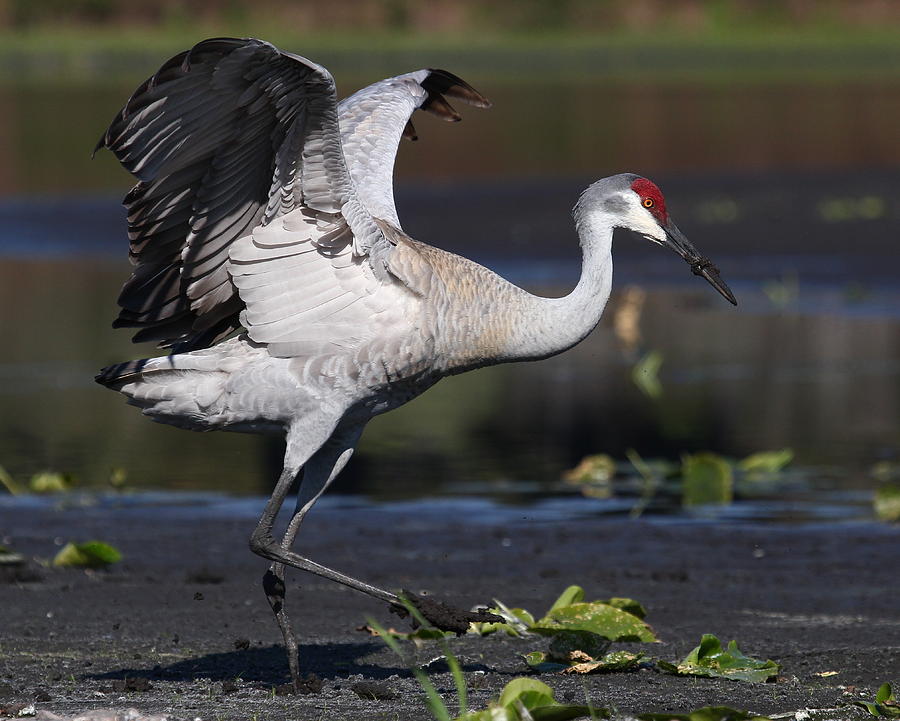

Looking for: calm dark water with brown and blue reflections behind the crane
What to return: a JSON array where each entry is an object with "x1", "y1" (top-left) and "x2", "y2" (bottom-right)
[{"x1": 0, "y1": 70, "x2": 900, "y2": 521}]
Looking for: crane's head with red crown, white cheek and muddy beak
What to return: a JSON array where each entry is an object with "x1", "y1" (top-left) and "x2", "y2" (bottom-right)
[{"x1": 585, "y1": 173, "x2": 737, "y2": 305}]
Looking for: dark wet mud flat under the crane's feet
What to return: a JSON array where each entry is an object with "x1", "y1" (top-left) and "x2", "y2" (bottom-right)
[{"x1": 0, "y1": 504, "x2": 900, "y2": 719}]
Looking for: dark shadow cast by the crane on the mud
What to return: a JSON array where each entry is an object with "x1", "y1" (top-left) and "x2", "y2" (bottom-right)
[{"x1": 86, "y1": 640, "x2": 491, "y2": 686}]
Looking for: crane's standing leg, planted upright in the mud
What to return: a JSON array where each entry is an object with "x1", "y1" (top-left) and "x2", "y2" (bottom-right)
[{"x1": 263, "y1": 426, "x2": 362, "y2": 693}]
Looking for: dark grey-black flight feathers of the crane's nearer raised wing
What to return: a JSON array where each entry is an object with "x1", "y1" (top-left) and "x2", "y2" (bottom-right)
[{"x1": 97, "y1": 38, "x2": 335, "y2": 350}]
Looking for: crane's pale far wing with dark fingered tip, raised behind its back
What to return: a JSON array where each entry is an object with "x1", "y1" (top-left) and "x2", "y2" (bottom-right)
[{"x1": 338, "y1": 69, "x2": 491, "y2": 228}]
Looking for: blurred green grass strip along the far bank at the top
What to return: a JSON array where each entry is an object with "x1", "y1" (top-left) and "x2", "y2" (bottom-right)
[{"x1": 0, "y1": 23, "x2": 900, "y2": 82}]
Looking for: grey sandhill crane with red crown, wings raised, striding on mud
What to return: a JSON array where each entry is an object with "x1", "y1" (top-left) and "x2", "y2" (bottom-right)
[{"x1": 97, "y1": 38, "x2": 735, "y2": 686}]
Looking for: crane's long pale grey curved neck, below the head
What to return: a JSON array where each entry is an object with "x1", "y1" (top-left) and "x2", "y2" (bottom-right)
[{"x1": 508, "y1": 204, "x2": 614, "y2": 360}]
